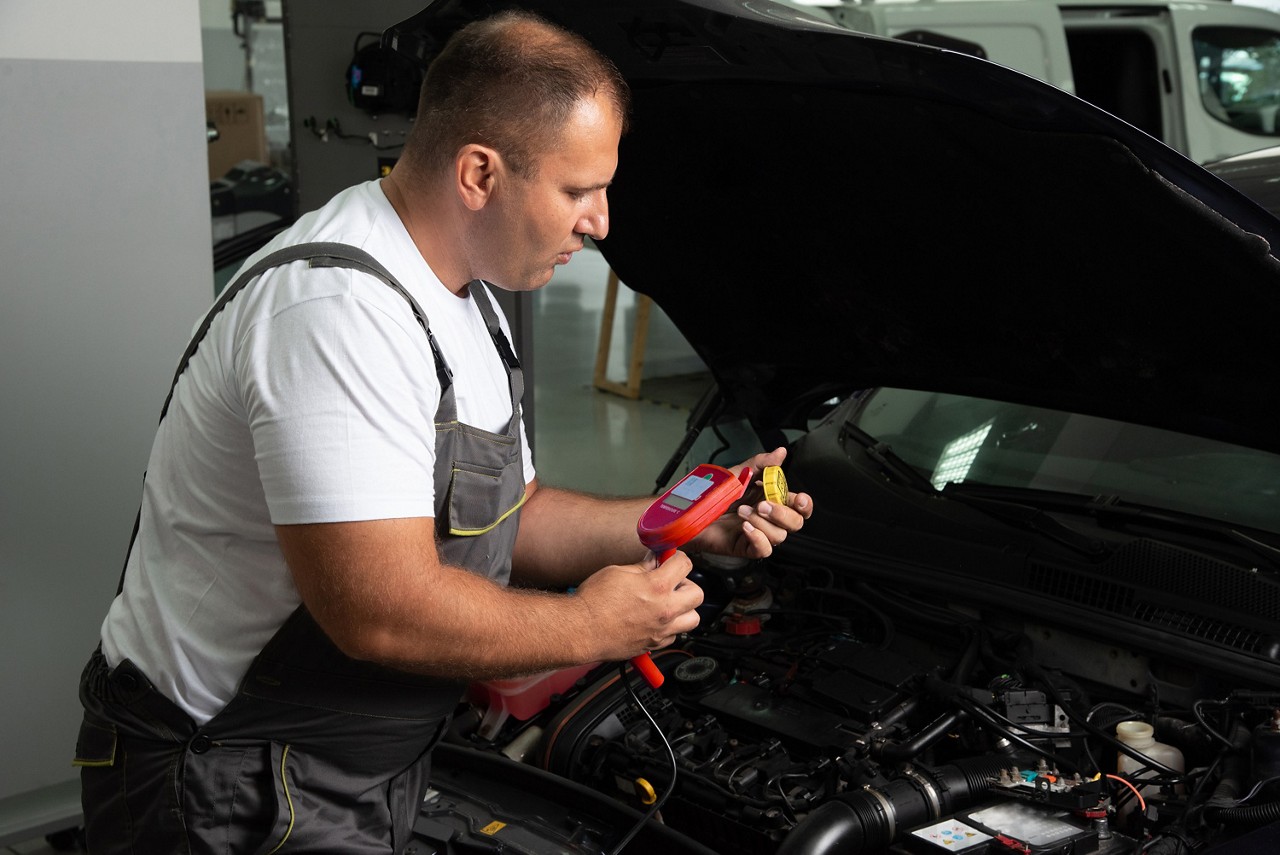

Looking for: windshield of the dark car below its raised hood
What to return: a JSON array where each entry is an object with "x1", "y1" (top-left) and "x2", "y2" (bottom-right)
[{"x1": 851, "y1": 389, "x2": 1280, "y2": 532}]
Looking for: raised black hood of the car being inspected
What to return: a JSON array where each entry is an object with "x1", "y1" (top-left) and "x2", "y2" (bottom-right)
[{"x1": 385, "y1": 0, "x2": 1280, "y2": 452}]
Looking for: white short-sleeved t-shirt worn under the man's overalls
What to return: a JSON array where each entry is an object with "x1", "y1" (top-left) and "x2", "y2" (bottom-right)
[{"x1": 102, "y1": 182, "x2": 534, "y2": 724}]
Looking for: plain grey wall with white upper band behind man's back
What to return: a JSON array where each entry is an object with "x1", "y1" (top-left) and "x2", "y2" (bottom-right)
[{"x1": 0, "y1": 0, "x2": 212, "y2": 831}]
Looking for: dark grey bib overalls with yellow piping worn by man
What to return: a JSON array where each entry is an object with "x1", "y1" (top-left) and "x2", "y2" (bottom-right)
[{"x1": 76, "y1": 243, "x2": 525, "y2": 855}]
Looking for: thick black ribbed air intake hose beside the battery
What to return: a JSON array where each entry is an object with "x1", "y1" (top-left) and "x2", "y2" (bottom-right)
[{"x1": 777, "y1": 758, "x2": 1006, "y2": 855}]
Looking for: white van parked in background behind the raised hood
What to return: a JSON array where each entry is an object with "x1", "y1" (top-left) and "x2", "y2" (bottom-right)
[{"x1": 792, "y1": 0, "x2": 1280, "y2": 163}]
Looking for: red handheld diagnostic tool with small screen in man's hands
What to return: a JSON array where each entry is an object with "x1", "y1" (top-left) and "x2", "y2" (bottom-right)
[{"x1": 631, "y1": 463, "x2": 751, "y2": 689}]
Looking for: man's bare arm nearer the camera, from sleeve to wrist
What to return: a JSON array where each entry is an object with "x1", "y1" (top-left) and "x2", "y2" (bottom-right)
[{"x1": 276, "y1": 517, "x2": 616, "y2": 678}]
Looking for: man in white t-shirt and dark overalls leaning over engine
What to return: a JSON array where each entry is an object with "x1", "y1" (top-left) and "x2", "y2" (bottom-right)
[{"x1": 76, "y1": 13, "x2": 813, "y2": 854}]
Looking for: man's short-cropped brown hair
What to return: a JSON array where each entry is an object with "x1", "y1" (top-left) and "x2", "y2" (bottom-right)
[{"x1": 406, "y1": 10, "x2": 630, "y2": 177}]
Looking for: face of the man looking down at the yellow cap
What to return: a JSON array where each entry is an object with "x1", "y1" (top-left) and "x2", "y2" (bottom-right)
[{"x1": 484, "y1": 95, "x2": 622, "y2": 291}]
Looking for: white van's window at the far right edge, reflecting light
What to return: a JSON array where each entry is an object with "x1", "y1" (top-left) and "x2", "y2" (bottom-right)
[{"x1": 1192, "y1": 27, "x2": 1280, "y2": 137}]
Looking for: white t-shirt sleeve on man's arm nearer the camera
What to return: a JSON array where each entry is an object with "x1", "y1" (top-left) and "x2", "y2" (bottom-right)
[{"x1": 236, "y1": 271, "x2": 440, "y2": 525}]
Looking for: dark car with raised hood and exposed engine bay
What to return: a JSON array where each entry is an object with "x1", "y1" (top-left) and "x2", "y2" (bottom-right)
[{"x1": 384, "y1": 0, "x2": 1280, "y2": 855}]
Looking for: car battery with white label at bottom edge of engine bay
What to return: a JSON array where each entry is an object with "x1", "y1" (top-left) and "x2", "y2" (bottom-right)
[{"x1": 904, "y1": 801, "x2": 1102, "y2": 855}]
